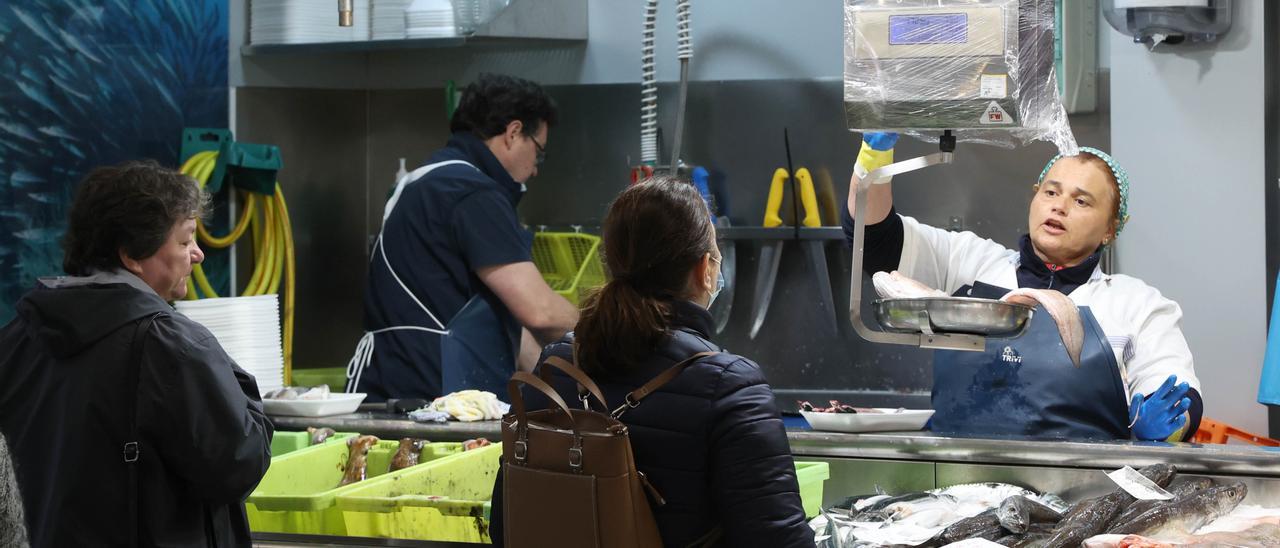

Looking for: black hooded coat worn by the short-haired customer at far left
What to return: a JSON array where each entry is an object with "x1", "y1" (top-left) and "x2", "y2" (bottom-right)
[{"x1": 0, "y1": 274, "x2": 273, "y2": 548}]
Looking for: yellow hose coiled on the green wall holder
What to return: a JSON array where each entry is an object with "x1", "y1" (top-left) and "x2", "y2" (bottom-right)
[{"x1": 180, "y1": 151, "x2": 296, "y2": 384}]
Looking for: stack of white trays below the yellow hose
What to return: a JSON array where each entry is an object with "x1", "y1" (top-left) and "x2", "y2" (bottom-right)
[{"x1": 174, "y1": 294, "x2": 284, "y2": 396}]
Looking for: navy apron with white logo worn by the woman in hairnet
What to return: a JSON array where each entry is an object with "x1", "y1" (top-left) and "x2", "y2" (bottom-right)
[{"x1": 931, "y1": 282, "x2": 1129, "y2": 439}]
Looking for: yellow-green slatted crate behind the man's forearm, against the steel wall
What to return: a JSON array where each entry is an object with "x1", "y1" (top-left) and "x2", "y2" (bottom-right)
[{"x1": 532, "y1": 232, "x2": 604, "y2": 305}]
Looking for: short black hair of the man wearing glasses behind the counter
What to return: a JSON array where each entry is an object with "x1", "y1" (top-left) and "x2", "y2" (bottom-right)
[{"x1": 449, "y1": 74, "x2": 558, "y2": 140}]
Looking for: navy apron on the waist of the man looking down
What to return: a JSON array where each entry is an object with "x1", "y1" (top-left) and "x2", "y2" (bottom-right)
[{"x1": 440, "y1": 292, "x2": 520, "y2": 396}]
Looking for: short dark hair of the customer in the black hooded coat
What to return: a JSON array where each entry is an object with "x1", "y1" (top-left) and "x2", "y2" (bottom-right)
[{"x1": 63, "y1": 160, "x2": 209, "y2": 275}]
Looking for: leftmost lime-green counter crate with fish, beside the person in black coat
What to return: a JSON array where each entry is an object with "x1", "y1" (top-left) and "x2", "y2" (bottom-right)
[{"x1": 244, "y1": 439, "x2": 462, "y2": 535}]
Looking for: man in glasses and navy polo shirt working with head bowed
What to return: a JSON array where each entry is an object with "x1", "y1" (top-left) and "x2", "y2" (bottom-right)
[{"x1": 348, "y1": 74, "x2": 577, "y2": 401}]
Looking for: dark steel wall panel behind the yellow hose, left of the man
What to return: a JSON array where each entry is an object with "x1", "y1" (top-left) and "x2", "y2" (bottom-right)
[{"x1": 236, "y1": 88, "x2": 369, "y2": 367}]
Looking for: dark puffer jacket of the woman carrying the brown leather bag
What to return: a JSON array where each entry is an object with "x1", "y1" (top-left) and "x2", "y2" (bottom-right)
[{"x1": 490, "y1": 302, "x2": 814, "y2": 548}]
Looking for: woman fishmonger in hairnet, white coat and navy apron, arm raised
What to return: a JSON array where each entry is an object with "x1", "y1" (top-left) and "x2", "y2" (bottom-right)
[{"x1": 844, "y1": 133, "x2": 1203, "y2": 440}]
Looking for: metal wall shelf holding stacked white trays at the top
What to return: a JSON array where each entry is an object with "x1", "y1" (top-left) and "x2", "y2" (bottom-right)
[{"x1": 241, "y1": 0, "x2": 588, "y2": 55}]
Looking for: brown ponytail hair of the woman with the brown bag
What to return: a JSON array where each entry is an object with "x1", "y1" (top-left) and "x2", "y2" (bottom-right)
[{"x1": 573, "y1": 175, "x2": 716, "y2": 374}]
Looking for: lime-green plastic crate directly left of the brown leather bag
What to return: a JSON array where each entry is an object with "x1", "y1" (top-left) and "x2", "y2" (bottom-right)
[{"x1": 338, "y1": 443, "x2": 502, "y2": 543}]
